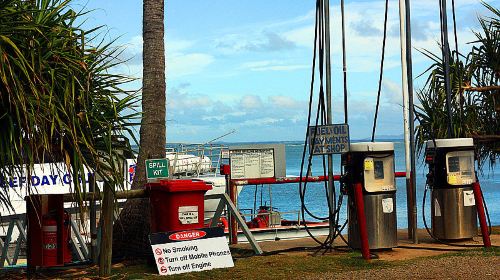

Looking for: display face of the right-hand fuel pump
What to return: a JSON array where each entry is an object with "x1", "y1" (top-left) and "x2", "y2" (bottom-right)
[{"x1": 446, "y1": 151, "x2": 476, "y2": 185}]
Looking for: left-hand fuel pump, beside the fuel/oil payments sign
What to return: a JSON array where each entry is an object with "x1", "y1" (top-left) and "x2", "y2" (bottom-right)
[{"x1": 342, "y1": 142, "x2": 397, "y2": 249}]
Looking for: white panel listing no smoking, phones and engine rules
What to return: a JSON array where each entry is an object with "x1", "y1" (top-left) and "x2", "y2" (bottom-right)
[{"x1": 151, "y1": 236, "x2": 234, "y2": 275}]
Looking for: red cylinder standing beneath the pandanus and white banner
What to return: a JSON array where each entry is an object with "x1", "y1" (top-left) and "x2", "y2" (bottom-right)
[{"x1": 42, "y1": 215, "x2": 58, "y2": 266}]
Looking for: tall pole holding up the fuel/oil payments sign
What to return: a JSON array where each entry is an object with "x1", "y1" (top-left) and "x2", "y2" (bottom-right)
[{"x1": 323, "y1": 0, "x2": 336, "y2": 241}]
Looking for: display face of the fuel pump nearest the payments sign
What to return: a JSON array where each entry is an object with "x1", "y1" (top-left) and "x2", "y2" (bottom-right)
[{"x1": 363, "y1": 155, "x2": 396, "y2": 192}]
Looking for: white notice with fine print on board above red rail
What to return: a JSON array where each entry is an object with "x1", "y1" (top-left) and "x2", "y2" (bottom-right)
[{"x1": 229, "y1": 148, "x2": 274, "y2": 179}]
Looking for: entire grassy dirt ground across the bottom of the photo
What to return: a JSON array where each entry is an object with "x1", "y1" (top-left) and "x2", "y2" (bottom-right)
[{"x1": 0, "y1": 227, "x2": 500, "y2": 280}]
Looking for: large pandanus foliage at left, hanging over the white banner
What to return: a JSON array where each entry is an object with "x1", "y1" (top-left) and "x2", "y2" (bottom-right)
[{"x1": 0, "y1": 0, "x2": 138, "y2": 213}]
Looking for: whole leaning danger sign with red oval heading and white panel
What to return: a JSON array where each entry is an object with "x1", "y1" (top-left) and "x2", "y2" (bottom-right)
[{"x1": 149, "y1": 227, "x2": 234, "y2": 275}]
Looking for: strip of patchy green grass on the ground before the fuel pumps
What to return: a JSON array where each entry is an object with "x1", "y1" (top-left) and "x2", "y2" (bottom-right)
[{"x1": 3, "y1": 242, "x2": 500, "y2": 279}]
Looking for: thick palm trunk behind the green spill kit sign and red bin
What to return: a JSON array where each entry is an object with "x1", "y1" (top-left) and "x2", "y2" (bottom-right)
[{"x1": 113, "y1": 0, "x2": 166, "y2": 259}]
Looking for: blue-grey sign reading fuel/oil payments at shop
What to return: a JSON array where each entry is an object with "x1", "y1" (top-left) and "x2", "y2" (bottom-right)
[{"x1": 308, "y1": 124, "x2": 349, "y2": 155}]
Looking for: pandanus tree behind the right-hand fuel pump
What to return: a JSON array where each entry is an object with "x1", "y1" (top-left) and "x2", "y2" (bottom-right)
[{"x1": 415, "y1": 3, "x2": 500, "y2": 167}]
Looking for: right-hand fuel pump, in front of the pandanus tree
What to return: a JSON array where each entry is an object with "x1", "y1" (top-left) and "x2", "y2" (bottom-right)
[{"x1": 424, "y1": 138, "x2": 477, "y2": 240}]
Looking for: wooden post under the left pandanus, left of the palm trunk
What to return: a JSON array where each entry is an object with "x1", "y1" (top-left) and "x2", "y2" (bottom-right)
[{"x1": 99, "y1": 182, "x2": 115, "y2": 277}]
